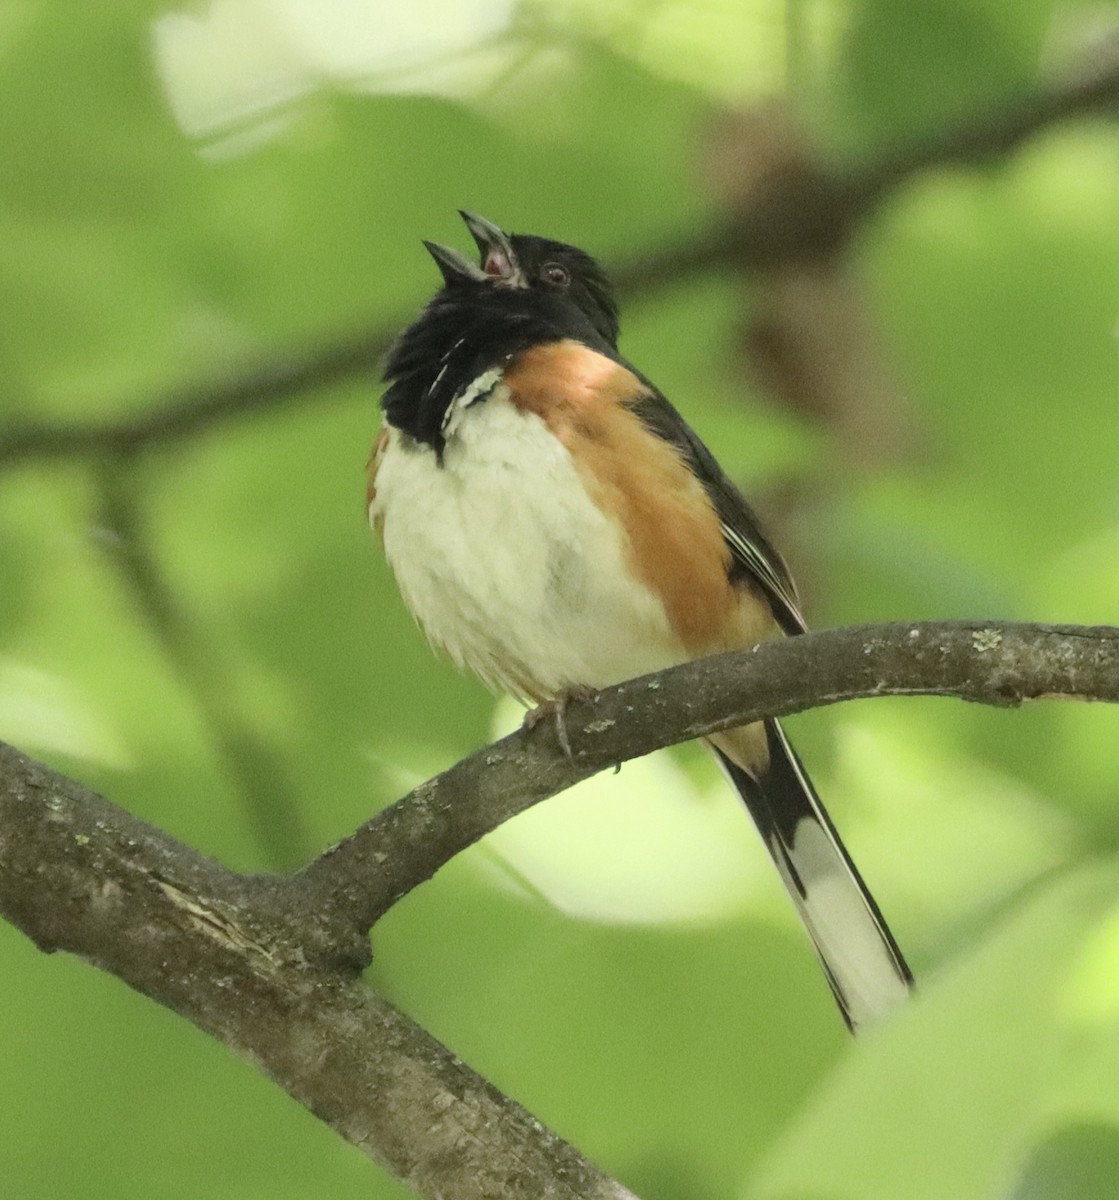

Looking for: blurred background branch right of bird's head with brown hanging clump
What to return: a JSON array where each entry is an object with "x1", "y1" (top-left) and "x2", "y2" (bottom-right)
[{"x1": 638, "y1": 42, "x2": 1119, "y2": 475}]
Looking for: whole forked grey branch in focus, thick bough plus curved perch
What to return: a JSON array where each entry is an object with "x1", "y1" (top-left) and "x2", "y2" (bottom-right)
[{"x1": 0, "y1": 622, "x2": 1119, "y2": 1200}]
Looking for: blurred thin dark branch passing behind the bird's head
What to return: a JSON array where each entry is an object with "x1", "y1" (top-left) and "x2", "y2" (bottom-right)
[{"x1": 0, "y1": 52, "x2": 1119, "y2": 464}]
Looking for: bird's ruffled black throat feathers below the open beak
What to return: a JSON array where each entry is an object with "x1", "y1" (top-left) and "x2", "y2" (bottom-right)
[{"x1": 381, "y1": 283, "x2": 617, "y2": 458}]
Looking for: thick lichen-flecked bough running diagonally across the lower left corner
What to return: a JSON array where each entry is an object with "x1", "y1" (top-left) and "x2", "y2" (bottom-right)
[{"x1": 0, "y1": 743, "x2": 632, "y2": 1200}]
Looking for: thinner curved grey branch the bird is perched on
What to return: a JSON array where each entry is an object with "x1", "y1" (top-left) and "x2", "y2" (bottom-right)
[{"x1": 303, "y1": 622, "x2": 1119, "y2": 928}]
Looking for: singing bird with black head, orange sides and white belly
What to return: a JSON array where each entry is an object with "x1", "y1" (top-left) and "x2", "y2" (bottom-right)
[{"x1": 367, "y1": 210, "x2": 912, "y2": 1033}]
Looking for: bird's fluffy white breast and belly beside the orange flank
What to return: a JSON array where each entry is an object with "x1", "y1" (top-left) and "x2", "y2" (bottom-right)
[{"x1": 370, "y1": 383, "x2": 687, "y2": 701}]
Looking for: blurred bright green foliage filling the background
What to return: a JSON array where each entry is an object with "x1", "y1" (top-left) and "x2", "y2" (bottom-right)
[{"x1": 0, "y1": 0, "x2": 1119, "y2": 1200}]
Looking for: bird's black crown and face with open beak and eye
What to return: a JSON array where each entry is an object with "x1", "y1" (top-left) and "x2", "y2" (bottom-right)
[{"x1": 424, "y1": 212, "x2": 618, "y2": 349}]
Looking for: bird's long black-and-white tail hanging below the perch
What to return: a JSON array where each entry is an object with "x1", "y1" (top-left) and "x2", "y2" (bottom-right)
[{"x1": 714, "y1": 721, "x2": 912, "y2": 1033}]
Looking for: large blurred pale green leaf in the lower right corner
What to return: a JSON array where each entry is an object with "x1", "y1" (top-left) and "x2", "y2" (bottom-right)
[{"x1": 747, "y1": 865, "x2": 1119, "y2": 1200}]
